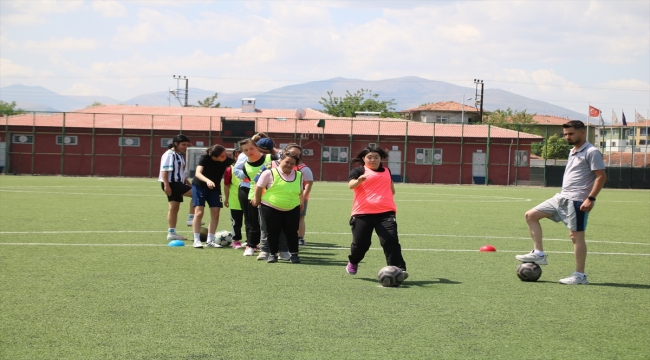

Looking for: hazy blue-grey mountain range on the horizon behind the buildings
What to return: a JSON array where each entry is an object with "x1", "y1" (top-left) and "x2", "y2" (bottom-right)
[{"x1": 0, "y1": 76, "x2": 585, "y2": 119}]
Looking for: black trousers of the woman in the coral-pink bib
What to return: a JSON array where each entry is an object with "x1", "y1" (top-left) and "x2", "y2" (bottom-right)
[{"x1": 348, "y1": 211, "x2": 406, "y2": 271}]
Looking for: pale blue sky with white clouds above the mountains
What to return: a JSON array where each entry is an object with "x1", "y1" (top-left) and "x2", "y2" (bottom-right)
[{"x1": 0, "y1": 0, "x2": 650, "y2": 119}]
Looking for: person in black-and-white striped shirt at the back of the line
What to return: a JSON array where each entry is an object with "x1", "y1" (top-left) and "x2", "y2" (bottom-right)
[{"x1": 158, "y1": 134, "x2": 194, "y2": 240}]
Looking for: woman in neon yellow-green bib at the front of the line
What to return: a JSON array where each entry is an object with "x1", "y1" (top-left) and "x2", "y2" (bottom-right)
[{"x1": 251, "y1": 152, "x2": 303, "y2": 264}]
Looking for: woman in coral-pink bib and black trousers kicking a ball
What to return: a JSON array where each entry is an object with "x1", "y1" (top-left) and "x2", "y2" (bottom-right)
[{"x1": 346, "y1": 147, "x2": 408, "y2": 279}]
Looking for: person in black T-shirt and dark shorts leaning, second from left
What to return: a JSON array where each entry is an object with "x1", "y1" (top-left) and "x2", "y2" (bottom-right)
[{"x1": 192, "y1": 144, "x2": 235, "y2": 249}]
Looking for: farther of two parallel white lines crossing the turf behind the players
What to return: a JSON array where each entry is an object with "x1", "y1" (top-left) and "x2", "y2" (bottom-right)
[{"x1": 0, "y1": 230, "x2": 650, "y2": 246}]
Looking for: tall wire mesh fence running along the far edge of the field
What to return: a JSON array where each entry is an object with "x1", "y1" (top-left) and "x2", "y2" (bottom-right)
[{"x1": 0, "y1": 112, "x2": 650, "y2": 188}]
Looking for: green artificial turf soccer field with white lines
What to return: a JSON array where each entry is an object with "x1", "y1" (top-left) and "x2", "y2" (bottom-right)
[{"x1": 0, "y1": 176, "x2": 650, "y2": 359}]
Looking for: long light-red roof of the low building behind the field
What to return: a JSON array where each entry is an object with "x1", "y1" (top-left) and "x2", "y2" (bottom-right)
[{"x1": 0, "y1": 106, "x2": 542, "y2": 139}]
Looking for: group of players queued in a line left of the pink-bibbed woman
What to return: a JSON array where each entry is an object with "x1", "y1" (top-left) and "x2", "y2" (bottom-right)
[{"x1": 159, "y1": 133, "x2": 314, "y2": 263}]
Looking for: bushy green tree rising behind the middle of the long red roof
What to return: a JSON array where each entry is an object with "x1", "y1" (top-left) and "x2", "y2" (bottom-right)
[{"x1": 318, "y1": 89, "x2": 400, "y2": 118}]
